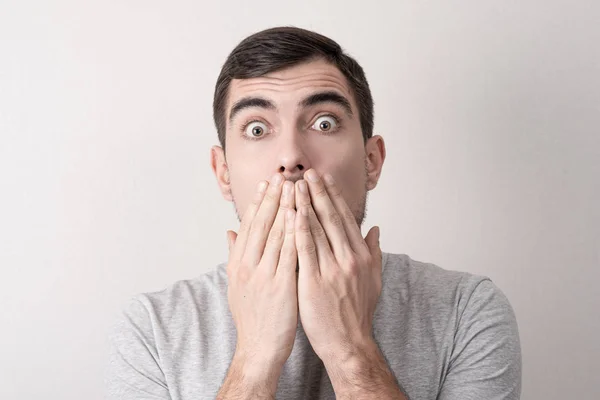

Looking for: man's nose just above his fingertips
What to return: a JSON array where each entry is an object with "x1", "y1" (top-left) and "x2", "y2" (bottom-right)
[{"x1": 276, "y1": 132, "x2": 311, "y2": 182}]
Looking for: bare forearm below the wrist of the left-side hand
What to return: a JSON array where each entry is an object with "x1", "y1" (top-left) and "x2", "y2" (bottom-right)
[{"x1": 216, "y1": 355, "x2": 281, "y2": 400}]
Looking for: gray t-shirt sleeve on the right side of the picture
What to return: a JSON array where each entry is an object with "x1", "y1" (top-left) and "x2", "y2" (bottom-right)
[{"x1": 438, "y1": 279, "x2": 521, "y2": 400}]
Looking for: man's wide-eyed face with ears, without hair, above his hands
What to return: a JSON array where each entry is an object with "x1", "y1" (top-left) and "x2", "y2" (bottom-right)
[{"x1": 211, "y1": 60, "x2": 385, "y2": 230}]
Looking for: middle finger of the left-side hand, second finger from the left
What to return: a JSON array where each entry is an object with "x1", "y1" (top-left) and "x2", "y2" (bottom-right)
[{"x1": 242, "y1": 173, "x2": 283, "y2": 266}]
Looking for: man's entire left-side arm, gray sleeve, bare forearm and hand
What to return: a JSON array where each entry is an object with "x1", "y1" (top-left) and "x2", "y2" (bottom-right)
[{"x1": 105, "y1": 177, "x2": 298, "y2": 400}]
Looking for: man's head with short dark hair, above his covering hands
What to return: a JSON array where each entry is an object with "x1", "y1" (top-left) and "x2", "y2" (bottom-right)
[{"x1": 211, "y1": 27, "x2": 385, "y2": 225}]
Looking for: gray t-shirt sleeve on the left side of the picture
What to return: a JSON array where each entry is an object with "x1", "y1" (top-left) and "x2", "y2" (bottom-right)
[{"x1": 105, "y1": 299, "x2": 171, "y2": 400}]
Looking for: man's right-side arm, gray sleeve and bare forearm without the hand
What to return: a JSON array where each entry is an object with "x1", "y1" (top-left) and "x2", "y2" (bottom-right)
[{"x1": 325, "y1": 280, "x2": 521, "y2": 400}]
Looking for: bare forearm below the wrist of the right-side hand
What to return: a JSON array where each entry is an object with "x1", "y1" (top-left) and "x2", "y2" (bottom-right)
[{"x1": 325, "y1": 342, "x2": 408, "y2": 400}]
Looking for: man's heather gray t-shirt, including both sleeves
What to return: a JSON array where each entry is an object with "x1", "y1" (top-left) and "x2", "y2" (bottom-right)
[{"x1": 106, "y1": 253, "x2": 521, "y2": 400}]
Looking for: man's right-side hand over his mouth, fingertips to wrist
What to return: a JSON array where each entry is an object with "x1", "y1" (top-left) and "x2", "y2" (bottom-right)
[{"x1": 295, "y1": 169, "x2": 382, "y2": 370}]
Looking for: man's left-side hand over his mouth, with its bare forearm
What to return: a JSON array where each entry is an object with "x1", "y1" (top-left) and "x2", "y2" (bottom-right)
[{"x1": 217, "y1": 174, "x2": 298, "y2": 398}]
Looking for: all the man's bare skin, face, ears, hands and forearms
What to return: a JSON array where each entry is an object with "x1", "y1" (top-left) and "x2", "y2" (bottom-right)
[{"x1": 211, "y1": 60, "x2": 405, "y2": 399}]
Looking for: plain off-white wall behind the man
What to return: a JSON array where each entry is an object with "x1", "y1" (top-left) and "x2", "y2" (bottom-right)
[{"x1": 0, "y1": 0, "x2": 600, "y2": 400}]
